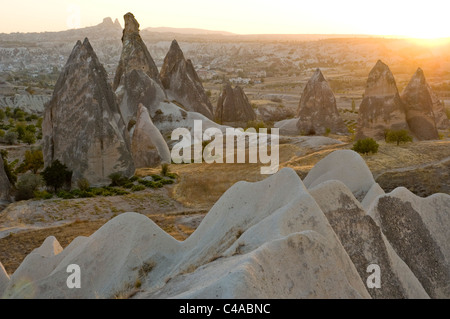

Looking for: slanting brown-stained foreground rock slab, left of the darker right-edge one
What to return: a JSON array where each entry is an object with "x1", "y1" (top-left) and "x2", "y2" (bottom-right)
[{"x1": 310, "y1": 180, "x2": 429, "y2": 299}]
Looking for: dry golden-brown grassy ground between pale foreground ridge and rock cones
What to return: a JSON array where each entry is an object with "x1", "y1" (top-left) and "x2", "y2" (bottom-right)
[{"x1": 0, "y1": 136, "x2": 450, "y2": 274}]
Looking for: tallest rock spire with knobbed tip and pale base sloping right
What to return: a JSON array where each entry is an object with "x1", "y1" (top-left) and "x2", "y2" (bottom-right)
[{"x1": 114, "y1": 13, "x2": 225, "y2": 139}]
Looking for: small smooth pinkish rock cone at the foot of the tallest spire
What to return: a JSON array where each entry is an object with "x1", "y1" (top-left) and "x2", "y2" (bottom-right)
[{"x1": 131, "y1": 104, "x2": 171, "y2": 168}]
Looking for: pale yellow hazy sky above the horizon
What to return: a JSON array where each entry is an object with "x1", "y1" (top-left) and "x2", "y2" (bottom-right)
[{"x1": 0, "y1": 0, "x2": 450, "y2": 38}]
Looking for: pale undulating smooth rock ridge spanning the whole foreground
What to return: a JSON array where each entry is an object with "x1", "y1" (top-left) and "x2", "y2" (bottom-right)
[{"x1": 0, "y1": 150, "x2": 450, "y2": 299}]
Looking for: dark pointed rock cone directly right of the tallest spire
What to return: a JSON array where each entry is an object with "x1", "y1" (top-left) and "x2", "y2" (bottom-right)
[{"x1": 161, "y1": 40, "x2": 213, "y2": 120}]
